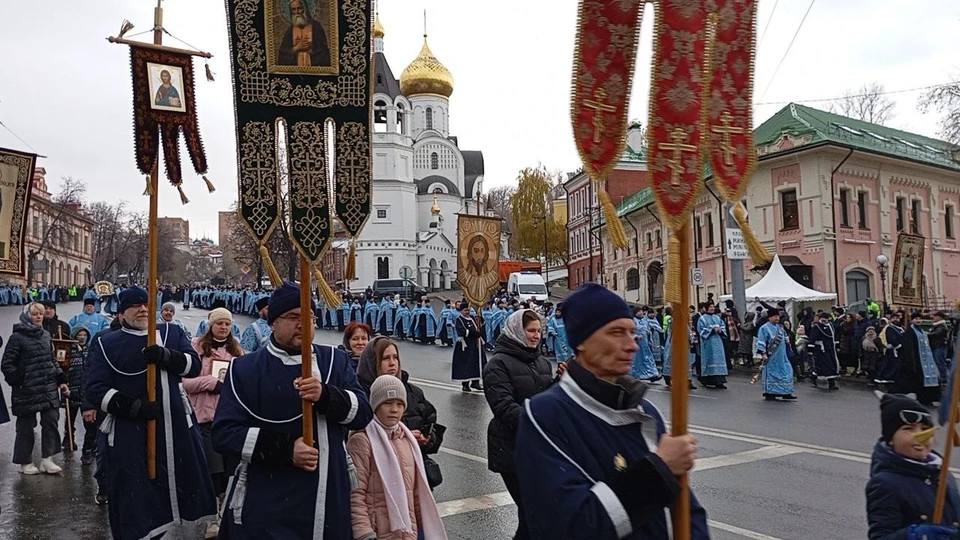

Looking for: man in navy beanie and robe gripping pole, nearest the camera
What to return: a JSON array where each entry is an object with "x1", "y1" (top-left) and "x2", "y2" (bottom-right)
[{"x1": 515, "y1": 283, "x2": 710, "y2": 540}]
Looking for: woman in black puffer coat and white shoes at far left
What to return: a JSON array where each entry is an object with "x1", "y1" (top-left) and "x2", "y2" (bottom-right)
[{"x1": 0, "y1": 302, "x2": 70, "y2": 474}]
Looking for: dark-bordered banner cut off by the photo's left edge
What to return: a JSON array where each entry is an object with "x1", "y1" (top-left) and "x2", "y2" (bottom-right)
[{"x1": 0, "y1": 148, "x2": 37, "y2": 276}]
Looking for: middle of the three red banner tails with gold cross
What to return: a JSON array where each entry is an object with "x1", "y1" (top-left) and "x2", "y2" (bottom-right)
[{"x1": 647, "y1": 0, "x2": 711, "y2": 230}]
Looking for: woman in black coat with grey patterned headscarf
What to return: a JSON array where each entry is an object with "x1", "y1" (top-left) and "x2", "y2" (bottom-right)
[{"x1": 483, "y1": 309, "x2": 565, "y2": 539}]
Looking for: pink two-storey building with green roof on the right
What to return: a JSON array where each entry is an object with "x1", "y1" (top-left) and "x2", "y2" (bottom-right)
[{"x1": 602, "y1": 104, "x2": 960, "y2": 305}]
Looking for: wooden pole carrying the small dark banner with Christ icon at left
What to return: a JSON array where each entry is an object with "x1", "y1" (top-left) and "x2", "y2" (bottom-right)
[{"x1": 147, "y1": 0, "x2": 163, "y2": 480}]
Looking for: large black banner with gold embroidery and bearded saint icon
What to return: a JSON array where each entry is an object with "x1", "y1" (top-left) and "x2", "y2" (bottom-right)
[{"x1": 227, "y1": 0, "x2": 373, "y2": 266}]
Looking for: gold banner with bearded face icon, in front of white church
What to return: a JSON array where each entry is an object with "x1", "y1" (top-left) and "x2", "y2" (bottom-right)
[{"x1": 457, "y1": 214, "x2": 502, "y2": 307}]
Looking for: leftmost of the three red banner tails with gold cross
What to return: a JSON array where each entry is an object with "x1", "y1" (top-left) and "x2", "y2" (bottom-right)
[{"x1": 570, "y1": 0, "x2": 644, "y2": 181}]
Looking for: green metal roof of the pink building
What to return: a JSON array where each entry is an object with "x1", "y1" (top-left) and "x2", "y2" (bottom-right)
[{"x1": 754, "y1": 103, "x2": 960, "y2": 171}]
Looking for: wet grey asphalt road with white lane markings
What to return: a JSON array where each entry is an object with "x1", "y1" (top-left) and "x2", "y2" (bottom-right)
[{"x1": 0, "y1": 303, "x2": 957, "y2": 540}]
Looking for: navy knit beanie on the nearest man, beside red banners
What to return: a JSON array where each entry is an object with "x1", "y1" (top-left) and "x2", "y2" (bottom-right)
[{"x1": 562, "y1": 283, "x2": 633, "y2": 350}]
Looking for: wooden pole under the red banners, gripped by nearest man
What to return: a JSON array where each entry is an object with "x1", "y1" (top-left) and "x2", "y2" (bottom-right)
[{"x1": 667, "y1": 220, "x2": 690, "y2": 540}]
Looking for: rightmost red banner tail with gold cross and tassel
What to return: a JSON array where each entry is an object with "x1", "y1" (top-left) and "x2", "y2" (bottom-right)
[{"x1": 706, "y1": 0, "x2": 757, "y2": 203}]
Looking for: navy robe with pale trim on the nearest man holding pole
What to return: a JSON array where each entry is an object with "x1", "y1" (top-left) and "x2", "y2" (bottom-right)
[{"x1": 514, "y1": 373, "x2": 710, "y2": 540}]
